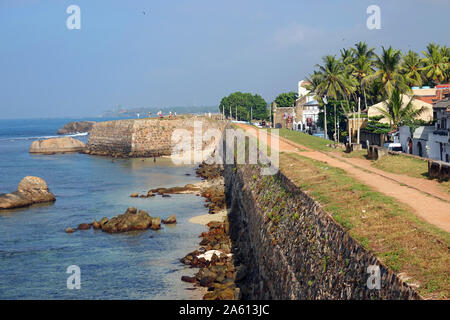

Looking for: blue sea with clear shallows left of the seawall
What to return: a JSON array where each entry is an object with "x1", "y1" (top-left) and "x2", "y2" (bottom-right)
[{"x1": 0, "y1": 119, "x2": 208, "y2": 299}]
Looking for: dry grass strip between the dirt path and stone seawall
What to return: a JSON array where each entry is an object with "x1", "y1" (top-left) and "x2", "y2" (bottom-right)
[{"x1": 280, "y1": 153, "x2": 450, "y2": 298}]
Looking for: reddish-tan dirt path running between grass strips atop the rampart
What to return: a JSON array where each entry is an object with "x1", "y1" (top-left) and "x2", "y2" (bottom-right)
[{"x1": 238, "y1": 124, "x2": 450, "y2": 232}]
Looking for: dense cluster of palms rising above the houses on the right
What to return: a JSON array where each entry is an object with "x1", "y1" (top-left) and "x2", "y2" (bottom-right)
[{"x1": 305, "y1": 42, "x2": 450, "y2": 138}]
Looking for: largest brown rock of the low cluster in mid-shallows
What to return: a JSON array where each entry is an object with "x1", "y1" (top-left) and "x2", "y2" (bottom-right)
[{"x1": 100, "y1": 207, "x2": 152, "y2": 233}]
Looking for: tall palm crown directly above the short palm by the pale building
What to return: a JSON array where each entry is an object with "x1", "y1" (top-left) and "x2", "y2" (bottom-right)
[{"x1": 369, "y1": 47, "x2": 411, "y2": 98}]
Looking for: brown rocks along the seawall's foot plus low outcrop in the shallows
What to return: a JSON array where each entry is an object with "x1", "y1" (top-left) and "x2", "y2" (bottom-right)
[{"x1": 66, "y1": 159, "x2": 239, "y2": 300}]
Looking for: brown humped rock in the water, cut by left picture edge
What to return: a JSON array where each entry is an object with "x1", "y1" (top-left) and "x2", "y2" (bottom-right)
[{"x1": 0, "y1": 176, "x2": 56, "y2": 209}]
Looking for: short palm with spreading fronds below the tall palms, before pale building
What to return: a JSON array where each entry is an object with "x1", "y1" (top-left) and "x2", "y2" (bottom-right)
[{"x1": 378, "y1": 88, "x2": 425, "y2": 129}]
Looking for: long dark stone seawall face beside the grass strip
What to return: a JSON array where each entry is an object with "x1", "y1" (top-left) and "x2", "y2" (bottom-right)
[{"x1": 224, "y1": 165, "x2": 420, "y2": 299}]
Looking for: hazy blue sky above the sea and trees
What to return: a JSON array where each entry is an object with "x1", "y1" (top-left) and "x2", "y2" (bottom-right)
[{"x1": 0, "y1": 0, "x2": 450, "y2": 118}]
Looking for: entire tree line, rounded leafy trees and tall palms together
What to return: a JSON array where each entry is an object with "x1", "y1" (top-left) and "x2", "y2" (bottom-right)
[{"x1": 219, "y1": 42, "x2": 450, "y2": 135}]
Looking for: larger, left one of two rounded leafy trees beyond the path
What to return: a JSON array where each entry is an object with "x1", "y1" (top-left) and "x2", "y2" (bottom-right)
[{"x1": 219, "y1": 92, "x2": 269, "y2": 120}]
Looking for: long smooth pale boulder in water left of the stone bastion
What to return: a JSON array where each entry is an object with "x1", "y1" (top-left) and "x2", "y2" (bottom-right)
[{"x1": 29, "y1": 137, "x2": 86, "y2": 154}]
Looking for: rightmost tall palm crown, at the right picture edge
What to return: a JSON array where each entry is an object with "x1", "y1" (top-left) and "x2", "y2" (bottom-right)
[{"x1": 422, "y1": 43, "x2": 448, "y2": 84}]
